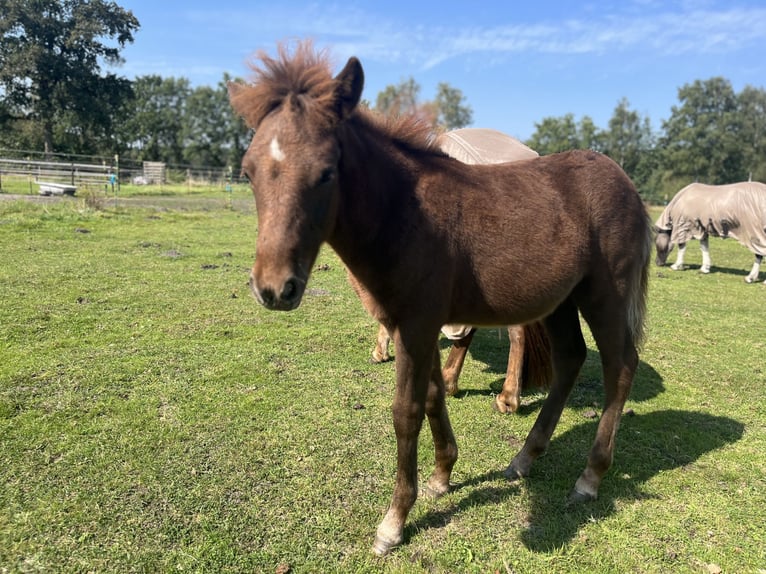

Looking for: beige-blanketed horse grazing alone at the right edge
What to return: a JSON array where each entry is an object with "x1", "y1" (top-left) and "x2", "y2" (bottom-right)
[{"x1": 655, "y1": 181, "x2": 766, "y2": 284}]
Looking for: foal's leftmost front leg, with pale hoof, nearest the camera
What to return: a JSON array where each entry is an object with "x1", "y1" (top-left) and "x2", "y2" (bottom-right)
[{"x1": 372, "y1": 332, "x2": 438, "y2": 556}]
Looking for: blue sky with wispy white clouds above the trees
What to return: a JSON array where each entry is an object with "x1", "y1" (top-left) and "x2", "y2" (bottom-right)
[{"x1": 116, "y1": 0, "x2": 766, "y2": 139}]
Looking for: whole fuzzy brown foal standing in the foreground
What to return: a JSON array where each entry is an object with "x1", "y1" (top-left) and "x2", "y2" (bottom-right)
[{"x1": 229, "y1": 43, "x2": 651, "y2": 555}]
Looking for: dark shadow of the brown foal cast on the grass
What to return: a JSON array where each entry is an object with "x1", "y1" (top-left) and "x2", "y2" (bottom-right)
[{"x1": 404, "y1": 410, "x2": 744, "y2": 553}]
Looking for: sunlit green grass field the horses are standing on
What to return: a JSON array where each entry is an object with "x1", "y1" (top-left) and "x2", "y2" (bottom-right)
[{"x1": 0, "y1": 199, "x2": 766, "y2": 573}]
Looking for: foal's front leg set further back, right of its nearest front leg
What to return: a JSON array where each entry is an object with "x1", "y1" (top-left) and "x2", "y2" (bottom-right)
[{"x1": 423, "y1": 347, "x2": 457, "y2": 498}]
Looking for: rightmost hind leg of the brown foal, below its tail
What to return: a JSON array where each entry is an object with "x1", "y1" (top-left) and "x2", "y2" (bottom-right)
[{"x1": 570, "y1": 312, "x2": 638, "y2": 502}]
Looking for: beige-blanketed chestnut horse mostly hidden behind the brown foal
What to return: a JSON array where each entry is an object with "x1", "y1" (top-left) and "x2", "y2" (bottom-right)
[{"x1": 370, "y1": 128, "x2": 553, "y2": 413}]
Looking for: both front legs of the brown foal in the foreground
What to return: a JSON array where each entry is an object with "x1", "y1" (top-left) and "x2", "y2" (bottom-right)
[{"x1": 372, "y1": 335, "x2": 457, "y2": 556}]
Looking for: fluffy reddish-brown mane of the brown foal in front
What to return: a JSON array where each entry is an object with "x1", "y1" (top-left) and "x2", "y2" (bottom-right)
[{"x1": 231, "y1": 41, "x2": 437, "y2": 158}]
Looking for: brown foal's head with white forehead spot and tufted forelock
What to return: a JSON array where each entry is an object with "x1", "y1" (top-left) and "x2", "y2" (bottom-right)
[{"x1": 229, "y1": 43, "x2": 364, "y2": 311}]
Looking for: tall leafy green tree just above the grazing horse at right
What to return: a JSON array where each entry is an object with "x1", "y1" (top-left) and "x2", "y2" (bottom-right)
[{"x1": 661, "y1": 77, "x2": 746, "y2": 184}]
